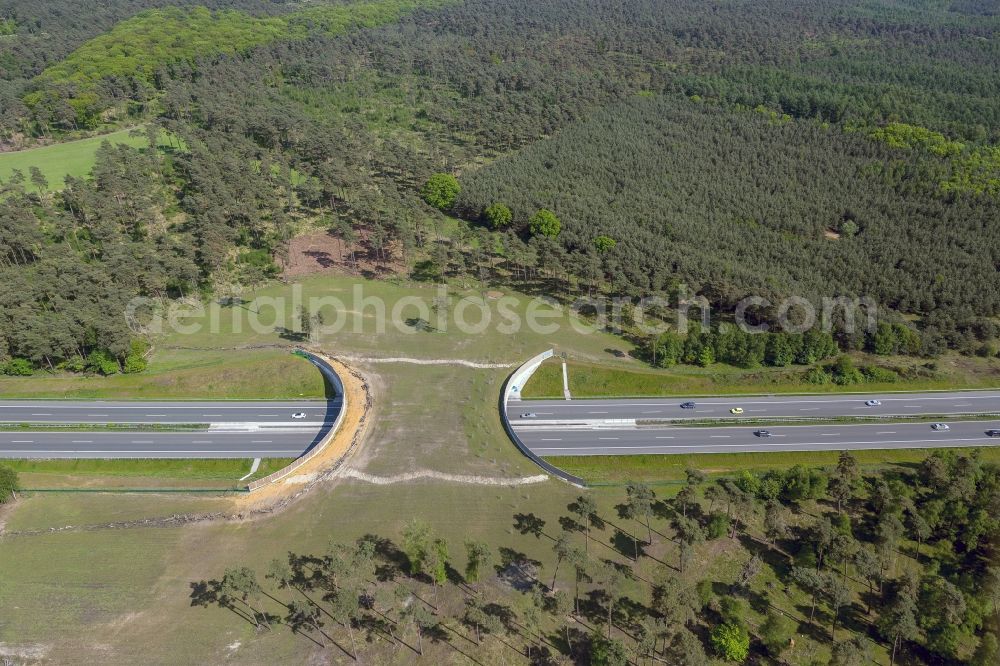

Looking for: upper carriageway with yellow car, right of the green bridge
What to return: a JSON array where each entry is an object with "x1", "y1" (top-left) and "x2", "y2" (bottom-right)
[{"x1": 509, "y1": 391, "x2": 1000, "y2": 422}]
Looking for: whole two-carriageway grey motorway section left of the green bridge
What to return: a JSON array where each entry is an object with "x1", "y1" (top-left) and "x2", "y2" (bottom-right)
[{"x1": 0, "y1": 399, "x2": 341, "y2": 458}]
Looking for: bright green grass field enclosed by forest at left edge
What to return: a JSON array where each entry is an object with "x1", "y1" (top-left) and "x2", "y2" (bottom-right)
[{"x1": 0, "y1": 130, "x2": 147, "y2": 191}]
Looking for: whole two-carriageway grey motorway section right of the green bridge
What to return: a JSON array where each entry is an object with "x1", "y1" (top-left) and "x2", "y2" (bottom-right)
[{"x1": 508, "y1": 390, "x2": 1000, "y2": 457}]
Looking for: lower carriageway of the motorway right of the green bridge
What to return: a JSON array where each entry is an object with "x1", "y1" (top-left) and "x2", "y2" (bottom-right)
[{"x1": 513, "y1": 419, "x2": 1000, "y2": 456}]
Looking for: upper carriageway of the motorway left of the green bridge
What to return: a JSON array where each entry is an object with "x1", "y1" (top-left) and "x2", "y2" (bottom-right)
[{"x1": 0, "y1": 398, "x2": 340, "y2": 424}]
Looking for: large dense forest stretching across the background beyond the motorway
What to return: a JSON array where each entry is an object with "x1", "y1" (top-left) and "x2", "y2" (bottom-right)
[{"x1": 0, "y1": 0, "x2": 1000, "y2": 371}]
